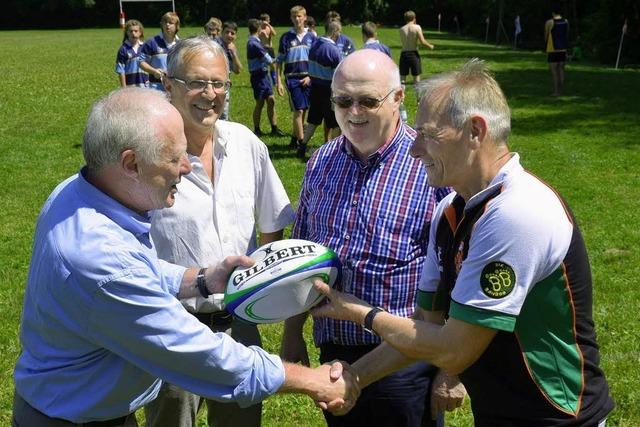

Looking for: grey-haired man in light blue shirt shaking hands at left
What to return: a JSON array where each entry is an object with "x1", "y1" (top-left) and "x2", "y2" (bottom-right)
[{"x1": 13, "y1": 88, "x2": 358, "y2": 426}]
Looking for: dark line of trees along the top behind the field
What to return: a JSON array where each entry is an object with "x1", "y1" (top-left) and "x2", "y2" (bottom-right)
[{"x1": 0, "y1": 0, "x2": 640, "y2": 67}]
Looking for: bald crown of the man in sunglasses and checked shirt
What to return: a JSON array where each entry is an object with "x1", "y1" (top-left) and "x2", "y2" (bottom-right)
[{"x1": 331, "y1": 49, "x2": 400, "y2": 90}]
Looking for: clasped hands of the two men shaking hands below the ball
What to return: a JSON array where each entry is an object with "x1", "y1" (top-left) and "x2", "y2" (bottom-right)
[{"x1": 279, "y1": 361, "x2": 360, "y2": 415}]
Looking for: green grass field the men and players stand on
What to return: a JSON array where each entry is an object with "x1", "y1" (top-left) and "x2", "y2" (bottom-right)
[{"x1": 0, "y1": 27, "x2": 640, "y2": 426}]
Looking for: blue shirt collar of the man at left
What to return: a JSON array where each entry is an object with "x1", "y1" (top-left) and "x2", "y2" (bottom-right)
[{"x1": 78, "y1": 166, "x2": 151, "y2": 236}]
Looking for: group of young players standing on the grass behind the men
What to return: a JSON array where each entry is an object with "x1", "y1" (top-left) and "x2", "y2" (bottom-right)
[{"x1": 115, "y1": 6, "x2": 434, "y2": 158}]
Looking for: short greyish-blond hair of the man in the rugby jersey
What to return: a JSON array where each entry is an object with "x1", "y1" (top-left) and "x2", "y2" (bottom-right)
[{"x1": 416, "y1": 58, "x2": 511, "y2": 143}]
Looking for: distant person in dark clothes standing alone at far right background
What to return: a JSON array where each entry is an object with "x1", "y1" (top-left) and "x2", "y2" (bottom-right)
[{"x1": 544, "y1": 6, "x2": 569, "y2": 96}]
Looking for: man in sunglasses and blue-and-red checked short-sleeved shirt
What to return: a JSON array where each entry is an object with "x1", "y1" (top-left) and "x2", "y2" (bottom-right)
[{"x1": 281, "y1": 50, "x2": 464, "y2": 427}]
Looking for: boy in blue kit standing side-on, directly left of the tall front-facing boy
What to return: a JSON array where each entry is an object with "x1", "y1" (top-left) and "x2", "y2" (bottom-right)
[{"x1": 247, "y1": 19, "x2": 284, "y2": 136}]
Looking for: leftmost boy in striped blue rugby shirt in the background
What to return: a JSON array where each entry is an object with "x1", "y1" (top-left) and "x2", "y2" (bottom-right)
[{"x1": 116, "y1": 19, "x2": 149, "y2": 87}]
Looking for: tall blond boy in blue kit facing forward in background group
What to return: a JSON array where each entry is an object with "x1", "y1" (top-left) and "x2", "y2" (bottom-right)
[{"x1": 276, "y1": 6, "x2": 316, "y2": 152}]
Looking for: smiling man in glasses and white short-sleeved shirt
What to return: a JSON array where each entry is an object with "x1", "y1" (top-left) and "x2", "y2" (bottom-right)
[{"x1": 146, "y1": 36, "x2": 294, "y2": 427}]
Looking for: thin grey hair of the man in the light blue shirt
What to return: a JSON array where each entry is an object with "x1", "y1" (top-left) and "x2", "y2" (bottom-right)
[{"x1": 82, "y1": 87, "x2": 170, "y2": 172}]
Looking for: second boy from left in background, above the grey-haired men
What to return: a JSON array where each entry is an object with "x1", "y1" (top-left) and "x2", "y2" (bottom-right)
[{"x1": 140, "y1": 12, "x2": 180, "y2": 91}]
